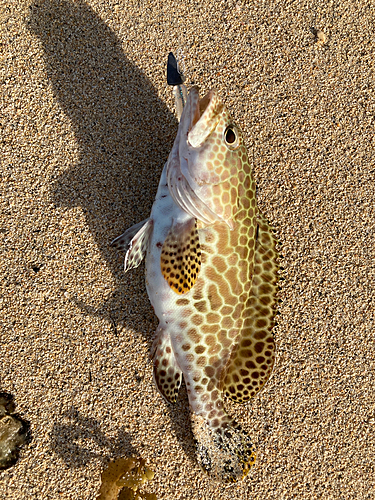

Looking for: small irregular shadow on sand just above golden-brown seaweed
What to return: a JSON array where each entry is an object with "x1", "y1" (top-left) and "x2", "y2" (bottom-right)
[{"x1": 50, "y1": 407, "x2": 137, "y2": 468}]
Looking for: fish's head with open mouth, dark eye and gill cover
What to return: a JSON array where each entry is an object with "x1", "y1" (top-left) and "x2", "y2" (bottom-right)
[{"x1": 167, "y1": 87, "x2": 250, "y2": 229}]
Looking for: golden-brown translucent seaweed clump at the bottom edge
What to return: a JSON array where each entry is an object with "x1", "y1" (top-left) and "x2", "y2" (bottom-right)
[{"x1": 97, "y1": 457, "x2": 157, "y2": 500}]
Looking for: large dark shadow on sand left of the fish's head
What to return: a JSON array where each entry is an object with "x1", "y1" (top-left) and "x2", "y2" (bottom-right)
[{"x1": 26, "y1": 0, "x2": 177, "y2": 316}]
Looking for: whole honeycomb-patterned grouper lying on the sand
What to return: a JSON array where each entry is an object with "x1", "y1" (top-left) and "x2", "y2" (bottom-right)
[{"x1": 112, "y1": 52, "x2": 279, "y2": 482}]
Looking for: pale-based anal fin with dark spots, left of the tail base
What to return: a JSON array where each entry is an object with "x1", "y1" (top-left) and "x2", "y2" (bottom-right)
[{"x1": 151, "y1": 325, "x2": 182, "y2": 403}]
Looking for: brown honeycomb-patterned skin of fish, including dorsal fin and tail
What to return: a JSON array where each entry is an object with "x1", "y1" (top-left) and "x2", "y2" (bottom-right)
[{"x1": 157, "y1": 101, "x2": 277, "y2": 481}]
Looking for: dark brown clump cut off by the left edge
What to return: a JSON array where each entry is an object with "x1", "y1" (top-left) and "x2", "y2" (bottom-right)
[{"x1": 0, "y1": 392, "x2": 30, "y2": 470}]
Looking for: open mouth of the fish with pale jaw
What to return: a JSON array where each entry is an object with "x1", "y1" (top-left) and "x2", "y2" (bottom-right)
[{"x1": 187, "y1": 87, "x2": 224, "y2": 148}]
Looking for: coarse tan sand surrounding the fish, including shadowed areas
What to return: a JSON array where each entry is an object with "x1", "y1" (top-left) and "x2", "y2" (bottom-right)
[{"x1": 0, "y1": 0, "x2": 375, "y2": 500}]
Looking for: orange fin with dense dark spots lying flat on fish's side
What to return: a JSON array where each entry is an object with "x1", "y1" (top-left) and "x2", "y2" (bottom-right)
[{"x1": 160, "y1": 218, "x2": 201, "y2": 294}]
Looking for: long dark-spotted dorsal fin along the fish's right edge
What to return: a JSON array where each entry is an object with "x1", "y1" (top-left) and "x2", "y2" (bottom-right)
[{"x1": 223, "y1": 214, "x2": 279, "y2": 403}]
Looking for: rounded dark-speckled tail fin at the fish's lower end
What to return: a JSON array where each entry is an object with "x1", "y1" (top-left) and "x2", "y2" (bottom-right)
[{"x1": 191, "y1": 413, "x2": 256, "y2": 482}]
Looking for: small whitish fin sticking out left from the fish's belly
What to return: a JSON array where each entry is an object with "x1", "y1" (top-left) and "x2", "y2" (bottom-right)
[{"x1": 111, "y1": 218, "x2": 153, "y2": 272}]
